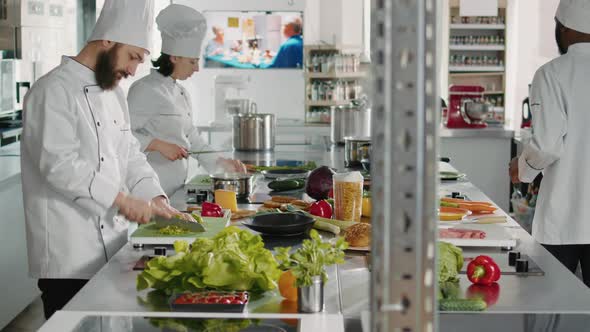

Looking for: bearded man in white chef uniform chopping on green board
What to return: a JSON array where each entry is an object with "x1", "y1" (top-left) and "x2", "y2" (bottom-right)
[{"x1": 21, "y1": 0, "x2": 192, "y2": 318}]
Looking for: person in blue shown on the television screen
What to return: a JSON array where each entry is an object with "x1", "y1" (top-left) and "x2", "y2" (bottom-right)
[{"x1": 261, "y1": 16, "x2": 303, "y2": 68}]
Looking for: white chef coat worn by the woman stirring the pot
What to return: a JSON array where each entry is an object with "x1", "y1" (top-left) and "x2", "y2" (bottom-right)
[{"x1": 127, "y1": 69, "x2": 217, "y2": 196}]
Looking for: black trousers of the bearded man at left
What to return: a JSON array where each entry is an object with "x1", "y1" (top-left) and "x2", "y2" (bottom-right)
[{"x1": 37, "y1": 279, "x2": 88, "y2": 319}]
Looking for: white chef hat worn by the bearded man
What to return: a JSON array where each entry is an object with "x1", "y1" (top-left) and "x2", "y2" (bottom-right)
[{"x1": 88, "y1": 0, "x2": 154, "y2": 53}]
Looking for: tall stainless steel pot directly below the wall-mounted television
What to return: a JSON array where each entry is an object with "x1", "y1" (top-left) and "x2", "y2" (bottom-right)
[{"x1": 233, "y1": 113, "x2": 276, "y2": 151}]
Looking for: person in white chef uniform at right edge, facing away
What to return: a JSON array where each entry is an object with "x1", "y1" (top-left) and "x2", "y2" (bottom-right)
[{"x1": 510, "y1": 0, "x2": 590, "y2": 287}]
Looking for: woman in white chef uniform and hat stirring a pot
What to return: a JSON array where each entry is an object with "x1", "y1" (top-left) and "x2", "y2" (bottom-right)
[{"x1": 127, "y1": 4, "x2": 245, "y2": 195}]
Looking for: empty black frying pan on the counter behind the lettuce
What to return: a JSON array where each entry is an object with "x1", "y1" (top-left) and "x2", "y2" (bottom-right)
[{"x1": 242, "y1": 213, "x2": 314, "y2": 236}]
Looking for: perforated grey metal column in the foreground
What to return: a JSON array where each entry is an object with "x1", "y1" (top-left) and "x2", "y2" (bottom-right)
[{"x1": 371, "y1": 0, "x2": 440, "y2": 332}]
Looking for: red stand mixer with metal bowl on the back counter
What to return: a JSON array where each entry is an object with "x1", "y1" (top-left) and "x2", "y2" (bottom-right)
[{"x1": 444, "y1": 85, "x2": 491, "y2": 128}]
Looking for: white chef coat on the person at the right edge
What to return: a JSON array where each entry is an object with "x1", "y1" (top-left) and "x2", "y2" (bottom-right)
[{"x1": 518, "y1": 43, "x2": 590, "y2": 245}]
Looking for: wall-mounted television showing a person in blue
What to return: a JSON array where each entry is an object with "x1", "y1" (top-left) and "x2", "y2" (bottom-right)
[{"x1": 202, "y1": 11, "x2": 303, "y2": 69}]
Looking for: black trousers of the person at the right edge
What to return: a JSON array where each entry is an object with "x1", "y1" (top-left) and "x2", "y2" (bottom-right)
[{"x1": 543, "y1": 244, "x2": 590, "y2": 287}]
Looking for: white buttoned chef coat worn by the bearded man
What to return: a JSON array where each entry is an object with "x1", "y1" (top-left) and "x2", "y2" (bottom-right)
[{"x1": 21, "y1": 57, "x2": 164, "y2": 279}]
